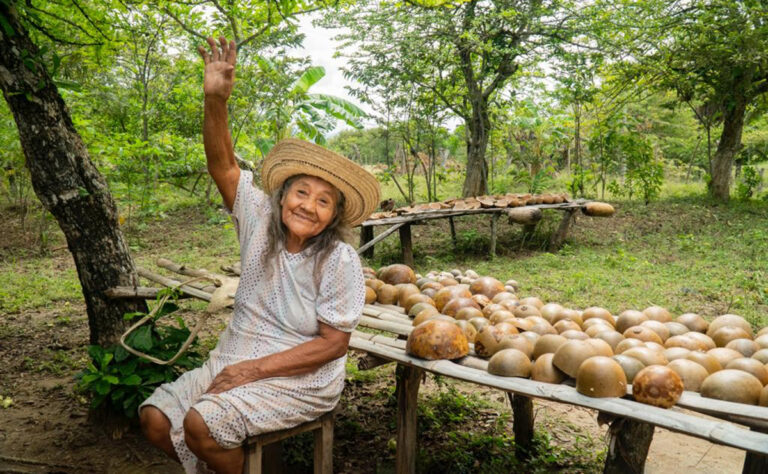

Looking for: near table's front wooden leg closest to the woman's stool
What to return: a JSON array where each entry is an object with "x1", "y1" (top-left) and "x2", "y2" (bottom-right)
[{"x1": 395, "y1": 364, "x2": 424, "y2": 474}]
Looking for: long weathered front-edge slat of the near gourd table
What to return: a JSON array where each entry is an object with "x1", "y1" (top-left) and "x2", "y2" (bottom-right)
[{"x1": 350, "y1": 336, "x2": 768, "y2": 454}]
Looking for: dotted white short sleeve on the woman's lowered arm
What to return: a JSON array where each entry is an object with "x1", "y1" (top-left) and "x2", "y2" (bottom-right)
[{"x1": 317, "y1": 243, "x2": 365, "y2": 332}]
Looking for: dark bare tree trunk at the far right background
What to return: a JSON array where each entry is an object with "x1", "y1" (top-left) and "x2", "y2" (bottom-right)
[{"x1": 710, "y1": 96, "x2": 747, "y2": 201}]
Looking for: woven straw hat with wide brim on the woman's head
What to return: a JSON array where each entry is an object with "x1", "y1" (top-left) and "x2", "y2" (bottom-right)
[{"x1": 261, "y1": 138, "x2": 379, "y2": 227}]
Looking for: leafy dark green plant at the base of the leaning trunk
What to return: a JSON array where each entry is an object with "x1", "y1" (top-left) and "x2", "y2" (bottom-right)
[{"x1": 77, "y1": 295, "x2": 202, "y2": 419}]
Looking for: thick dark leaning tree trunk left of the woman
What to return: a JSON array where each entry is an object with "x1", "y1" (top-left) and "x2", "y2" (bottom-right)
[{"x1": 0, "y1": 2, "x2": 146, "y2": 345}]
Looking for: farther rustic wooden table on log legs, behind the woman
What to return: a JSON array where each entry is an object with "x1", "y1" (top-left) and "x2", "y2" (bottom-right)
[{"x1": 357, "y1": 199, "x2": 590, "y2": 267}]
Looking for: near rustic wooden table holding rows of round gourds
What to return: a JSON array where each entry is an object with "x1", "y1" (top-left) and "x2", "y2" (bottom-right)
[{"x1": 349, "y1": 305, "x2": 768, "y2": 474}]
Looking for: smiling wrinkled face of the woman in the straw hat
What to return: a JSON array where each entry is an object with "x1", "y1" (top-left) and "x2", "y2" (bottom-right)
[{"x1": 280, "y1": 176, "x2": 339, "y2": 253}]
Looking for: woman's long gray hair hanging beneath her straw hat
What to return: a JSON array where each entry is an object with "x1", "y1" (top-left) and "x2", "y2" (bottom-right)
[{"x1": 262, "y1": 174, "x2": 350, "y2": 284}]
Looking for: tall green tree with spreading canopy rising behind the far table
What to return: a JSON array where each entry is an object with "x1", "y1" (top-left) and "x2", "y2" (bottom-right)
[{"x1": 324, "y1": 0, "x2": 567, "y2": 196}]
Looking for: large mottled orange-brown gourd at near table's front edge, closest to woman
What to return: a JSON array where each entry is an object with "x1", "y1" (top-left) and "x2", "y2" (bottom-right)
[{"x1": 405, "y1": 320, "x2": 469, "y2": 360}]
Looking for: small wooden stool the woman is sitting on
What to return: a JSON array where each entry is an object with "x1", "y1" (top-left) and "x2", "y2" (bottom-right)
[{"x1": 243, "y1": 409, "x2": 336, "y2": 474}]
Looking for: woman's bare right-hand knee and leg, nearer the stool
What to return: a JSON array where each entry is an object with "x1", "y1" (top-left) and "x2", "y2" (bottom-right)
[{"x1": 184, "y1": 408, "x2": 245, "y2": 474}]
